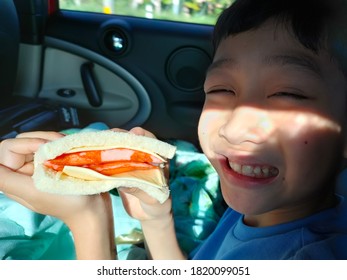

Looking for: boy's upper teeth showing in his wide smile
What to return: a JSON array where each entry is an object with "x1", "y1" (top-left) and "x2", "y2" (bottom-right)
[{"x1": 229, "y1": 162, "x2": 278, "y2": 178}]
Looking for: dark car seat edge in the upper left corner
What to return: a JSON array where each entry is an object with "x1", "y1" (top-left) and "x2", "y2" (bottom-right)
[{"x1": 0, "y1": 0, "x2": 20, "y2": 101}]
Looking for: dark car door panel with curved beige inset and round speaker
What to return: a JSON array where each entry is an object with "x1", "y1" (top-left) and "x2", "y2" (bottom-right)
[{"x1": 12, "y1": 0, "x2": 212, "y2": 145}]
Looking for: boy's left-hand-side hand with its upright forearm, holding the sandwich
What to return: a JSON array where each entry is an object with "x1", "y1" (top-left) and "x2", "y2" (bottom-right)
[{"x1": 0, "y1": 132, "x2": 116, "y2": 260}]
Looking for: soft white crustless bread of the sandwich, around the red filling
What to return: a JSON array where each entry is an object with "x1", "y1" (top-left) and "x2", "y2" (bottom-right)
[{"x1": 33, "y1": 130, "x2": 176, "y2": 203}]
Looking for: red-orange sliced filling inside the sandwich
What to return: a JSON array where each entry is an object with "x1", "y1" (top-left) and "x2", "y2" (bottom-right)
[{"x1": 44, "y1": 148, "x2": 163, "y2": 175}]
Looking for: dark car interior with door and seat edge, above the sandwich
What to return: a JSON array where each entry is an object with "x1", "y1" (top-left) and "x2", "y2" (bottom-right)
[{"x1": 0, "y1": 0, "x2": 212, "y2": 148}]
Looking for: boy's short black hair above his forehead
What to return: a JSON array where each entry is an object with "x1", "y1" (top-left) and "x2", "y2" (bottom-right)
[{"x1": 213, "y1": 0, "x2": 347, "y2": 72}]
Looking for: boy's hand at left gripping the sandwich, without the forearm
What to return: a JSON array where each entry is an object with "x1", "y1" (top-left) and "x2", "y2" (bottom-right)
[{"x1": 0, "y1": 132, "x2": 111, "y2": 228}]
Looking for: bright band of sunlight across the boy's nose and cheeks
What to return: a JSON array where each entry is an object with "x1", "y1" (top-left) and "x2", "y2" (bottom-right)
[{"x1": 199, "y1": 106, "x2": 343, "y2": 160}]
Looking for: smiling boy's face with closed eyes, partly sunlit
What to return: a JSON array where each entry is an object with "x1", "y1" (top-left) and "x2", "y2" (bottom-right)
[{"x1": 199, "y1": 21, "x2": 346, "y2": 225}]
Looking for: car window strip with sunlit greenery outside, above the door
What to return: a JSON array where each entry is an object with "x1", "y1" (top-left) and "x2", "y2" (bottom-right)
[{"x1": 59, "y1": 0, "x2": 232, "y2": 25}]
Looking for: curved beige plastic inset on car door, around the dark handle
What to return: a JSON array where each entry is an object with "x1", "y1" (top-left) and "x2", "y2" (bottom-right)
[{"x1": 39, "y1": 37, "x2": 151, "y2": 127}]
